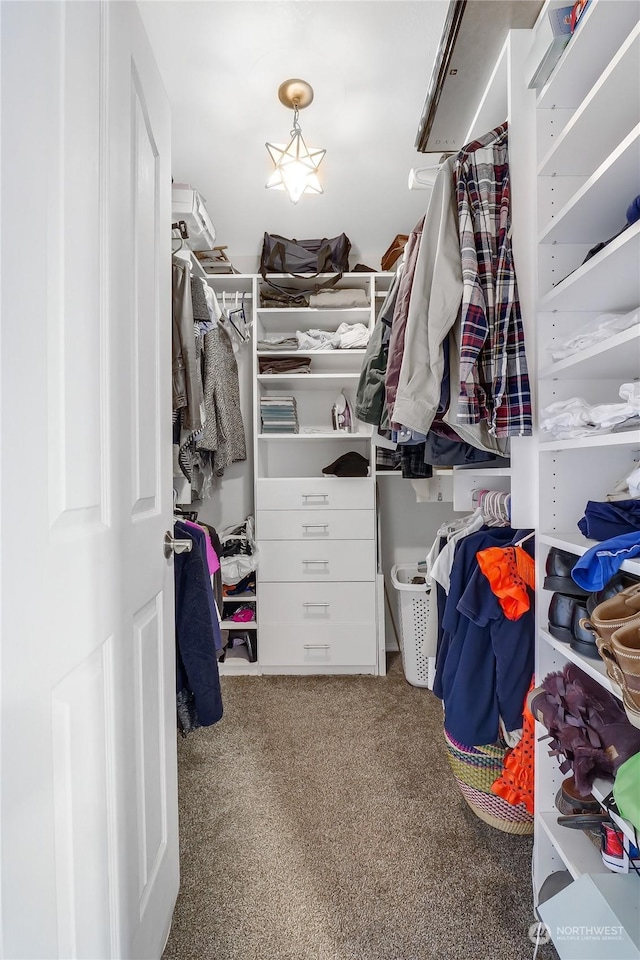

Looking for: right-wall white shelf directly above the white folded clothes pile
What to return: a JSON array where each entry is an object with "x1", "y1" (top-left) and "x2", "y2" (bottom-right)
[{"x1": 540, "y1": 323, "x2": 640, "y2": 383}]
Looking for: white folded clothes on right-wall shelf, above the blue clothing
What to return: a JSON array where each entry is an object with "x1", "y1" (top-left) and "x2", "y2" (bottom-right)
[{"x1": 540, "y1": 380, "x2": 640, "y2": 440}]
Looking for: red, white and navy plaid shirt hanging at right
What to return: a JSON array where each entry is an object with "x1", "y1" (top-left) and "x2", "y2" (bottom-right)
[{"x1": 454, "y1": 123, "x2": 532, "y2": 437}]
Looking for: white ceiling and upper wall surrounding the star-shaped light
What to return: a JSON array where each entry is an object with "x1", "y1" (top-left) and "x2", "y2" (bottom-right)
[{"x1": 139, "y1": 0, "x2": 448, "y2": 271}]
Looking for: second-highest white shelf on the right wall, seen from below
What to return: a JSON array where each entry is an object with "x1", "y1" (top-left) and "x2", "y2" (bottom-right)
[{"x1": 538, "y1": 24, "x2": 640, "y2": 177}]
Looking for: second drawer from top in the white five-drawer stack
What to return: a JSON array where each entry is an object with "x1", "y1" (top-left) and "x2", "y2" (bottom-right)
[{"x1": 256, "y1": 510, "x2": 375, "y2": 540}]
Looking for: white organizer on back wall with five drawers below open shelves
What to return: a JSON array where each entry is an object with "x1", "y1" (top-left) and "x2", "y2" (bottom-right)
[{"x1": 207, "y1": 273, "x2": 392, "y2": 674}]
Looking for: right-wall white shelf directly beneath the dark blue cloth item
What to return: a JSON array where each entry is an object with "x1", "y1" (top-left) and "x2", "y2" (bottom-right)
[{"x1": 538, "y1": 221, "x2": 640, "y2": 313}]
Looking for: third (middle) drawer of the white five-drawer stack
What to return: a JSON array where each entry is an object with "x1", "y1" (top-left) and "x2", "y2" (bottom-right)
[{"x1": 258, "y1": 540, "x2": 376, "y2": 583}]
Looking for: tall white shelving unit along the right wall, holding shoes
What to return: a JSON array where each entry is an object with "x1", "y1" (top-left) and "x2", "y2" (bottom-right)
[{"x1": 534, "y1": 0, "x2": 640, "y2": 960}]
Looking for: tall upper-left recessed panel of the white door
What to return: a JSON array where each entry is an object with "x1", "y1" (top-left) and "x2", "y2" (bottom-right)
[{"x1": 49, "y1": 3, "x2": 108, "y2": 526}]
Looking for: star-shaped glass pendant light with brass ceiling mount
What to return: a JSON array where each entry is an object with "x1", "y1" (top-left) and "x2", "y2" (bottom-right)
[{"x1": 265, "y1": 79, "x2": 327, "y2": 203}]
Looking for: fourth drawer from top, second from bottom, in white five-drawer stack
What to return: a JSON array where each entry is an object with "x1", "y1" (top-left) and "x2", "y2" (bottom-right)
[{"x1": 258, "y1": 582, "x2": 376, "y2": 630}]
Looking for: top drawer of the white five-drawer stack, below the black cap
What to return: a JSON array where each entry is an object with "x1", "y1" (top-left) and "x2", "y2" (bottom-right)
[{"x1": 256, "y1": 478, "x2": 375, "y2": 510}]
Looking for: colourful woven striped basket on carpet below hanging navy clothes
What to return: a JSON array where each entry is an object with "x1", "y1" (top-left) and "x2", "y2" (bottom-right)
[{"x1": 444, "y1": 730, "x2": 533, "y2": 836}]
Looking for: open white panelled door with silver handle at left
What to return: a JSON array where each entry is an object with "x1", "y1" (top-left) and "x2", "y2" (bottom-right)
[{"x1": 0, "y1": 2, "x2": 178, "y2": 960}]
